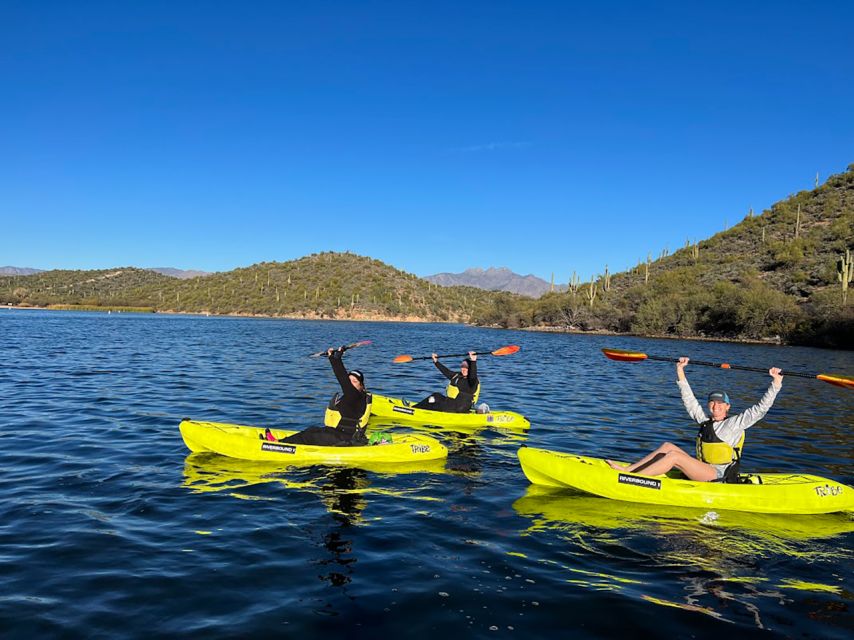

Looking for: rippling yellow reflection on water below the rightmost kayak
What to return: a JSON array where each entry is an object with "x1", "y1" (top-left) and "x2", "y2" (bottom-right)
[{"x1": 513, "y1": 485, "x2": 854, "y2": 629}]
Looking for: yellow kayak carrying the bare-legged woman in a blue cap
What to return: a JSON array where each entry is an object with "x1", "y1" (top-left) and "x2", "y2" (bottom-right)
[{"x1": 518, "y1": 447, "x2": 854, "y2": 514}]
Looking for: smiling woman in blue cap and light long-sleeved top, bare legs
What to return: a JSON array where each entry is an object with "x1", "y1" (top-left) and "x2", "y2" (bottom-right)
[{"x1": 606, "y1": 357, "x2": 783, "y2": 482}]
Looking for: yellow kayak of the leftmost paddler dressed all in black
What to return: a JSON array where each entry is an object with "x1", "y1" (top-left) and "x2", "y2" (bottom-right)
[{"x1": 179, "y1": 420, "x2": 448, "y2": 466}]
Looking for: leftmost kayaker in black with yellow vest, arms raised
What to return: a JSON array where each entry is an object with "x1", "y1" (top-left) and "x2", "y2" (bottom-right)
[{"x1": 274, "y1": 347, "x2": 370, "y2": 447}]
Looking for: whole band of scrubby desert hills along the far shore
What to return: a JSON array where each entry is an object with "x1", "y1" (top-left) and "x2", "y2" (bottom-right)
[{"x1": 0, "y1": 164, "x2": 854, "y2": 349}]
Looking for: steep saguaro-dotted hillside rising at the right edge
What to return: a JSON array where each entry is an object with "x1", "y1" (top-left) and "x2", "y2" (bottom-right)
[{"x1": 477, "y1": 165, "x2": 854, "y2": 348}]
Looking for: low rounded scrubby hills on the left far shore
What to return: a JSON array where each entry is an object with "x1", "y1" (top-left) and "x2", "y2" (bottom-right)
[{"x1": 0, "y1": 253, "x2": 508, "y2": 321}]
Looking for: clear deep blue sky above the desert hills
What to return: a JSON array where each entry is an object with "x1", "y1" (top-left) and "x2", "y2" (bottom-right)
[{"x1": 0, "y1": 0, "x2": 854, "y2": 281}]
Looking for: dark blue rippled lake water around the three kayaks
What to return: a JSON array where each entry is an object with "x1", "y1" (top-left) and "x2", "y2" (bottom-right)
[{"x1": 0, "y1": 310, "x2": 854, "y2": 638}]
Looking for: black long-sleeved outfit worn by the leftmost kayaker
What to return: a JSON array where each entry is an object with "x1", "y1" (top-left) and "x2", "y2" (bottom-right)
[{"x1": 279, "y1": 351, "x2": 368, "y2": 447}]
